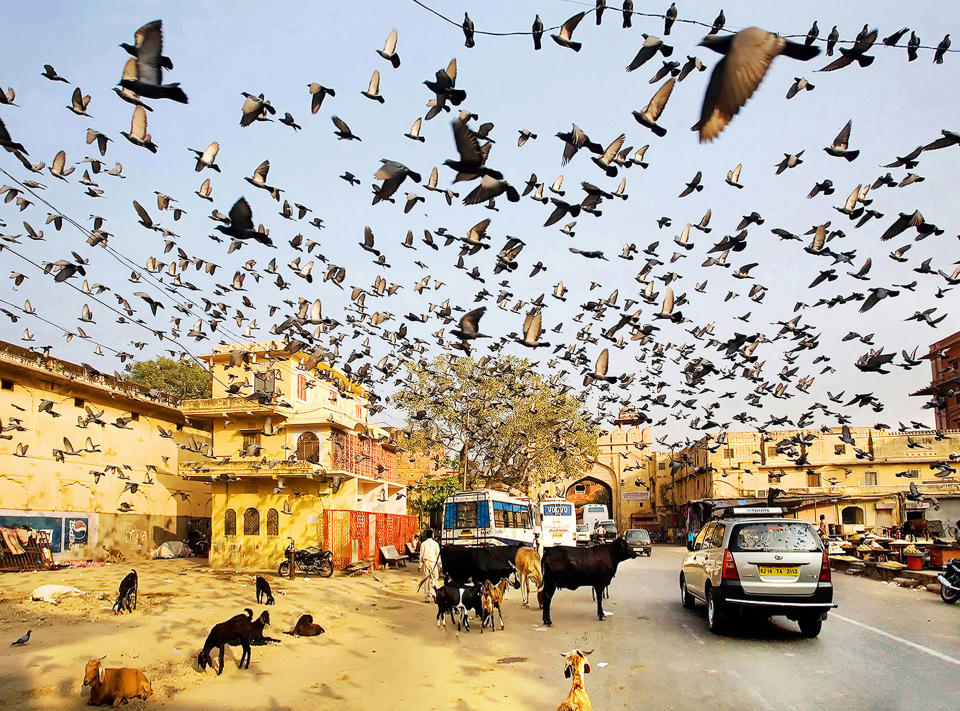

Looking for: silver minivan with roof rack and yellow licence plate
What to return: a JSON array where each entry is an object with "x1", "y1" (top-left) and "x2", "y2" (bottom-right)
[{"x1": 680, "y1": 507, "x2": 836, "y2": 637}]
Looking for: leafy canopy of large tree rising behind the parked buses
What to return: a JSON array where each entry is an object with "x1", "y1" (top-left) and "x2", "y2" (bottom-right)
[{"x1": 391, "y1": 356, "x2": 597, "y2": 493}]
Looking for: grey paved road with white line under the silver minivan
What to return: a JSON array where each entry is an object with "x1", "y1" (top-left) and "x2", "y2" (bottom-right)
[{"x1": 535, "y1": 546, "x2": 960, "y2": 711}]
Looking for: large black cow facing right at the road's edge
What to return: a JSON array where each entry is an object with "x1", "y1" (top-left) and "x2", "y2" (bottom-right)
[{"x1": 543, "y1": 536, "x2": 637, "y2": 625}]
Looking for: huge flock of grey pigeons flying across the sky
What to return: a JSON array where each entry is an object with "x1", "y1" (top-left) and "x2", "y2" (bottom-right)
[{"x1": 0, "y1": 0, "x2": 960, "y2": 484}]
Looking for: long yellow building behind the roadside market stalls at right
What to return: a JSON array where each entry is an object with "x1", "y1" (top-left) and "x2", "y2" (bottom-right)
[{"x1": 649, "y1": 427, "x2": 960, "y2": 533}]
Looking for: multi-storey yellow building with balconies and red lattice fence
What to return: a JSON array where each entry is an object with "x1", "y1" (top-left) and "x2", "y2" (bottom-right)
[{"x1": 180, "y1": 341, "x2": 416, "y2": 570}]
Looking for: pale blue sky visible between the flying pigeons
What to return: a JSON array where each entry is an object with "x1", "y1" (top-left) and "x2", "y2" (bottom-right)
[{"x1": 0, "y1": 0, "x2": 960, "y2": 438}]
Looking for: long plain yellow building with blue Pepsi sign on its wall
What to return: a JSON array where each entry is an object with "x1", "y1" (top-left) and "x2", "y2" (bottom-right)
[{"x1": 0, "y1": 341, "x2": 211, "y2": 560}]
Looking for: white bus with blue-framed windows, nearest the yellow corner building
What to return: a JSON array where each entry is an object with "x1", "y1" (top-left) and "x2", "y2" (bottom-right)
[{"x1": 440, "y1": 489, "x2": 540, "y2": 546}]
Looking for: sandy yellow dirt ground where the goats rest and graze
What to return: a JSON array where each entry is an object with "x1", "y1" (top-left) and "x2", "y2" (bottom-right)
[{"x1": 0, "y1": 559, "x2": 574, "y2": 711}]
